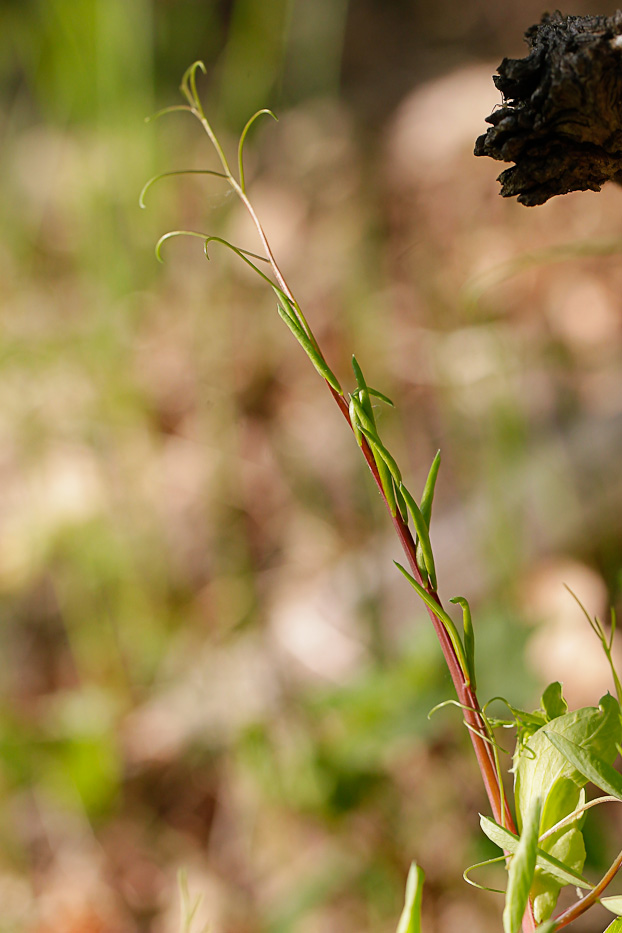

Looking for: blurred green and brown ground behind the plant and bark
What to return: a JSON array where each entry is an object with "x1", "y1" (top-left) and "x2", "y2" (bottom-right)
[{"x1": 0, "y1": 0, "x2": 622, "y2": 933}]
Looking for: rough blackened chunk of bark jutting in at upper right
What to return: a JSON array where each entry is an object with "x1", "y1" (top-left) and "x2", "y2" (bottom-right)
[{"x1": 475, "y1": 11, "x2": 622, "y2": 206}]
